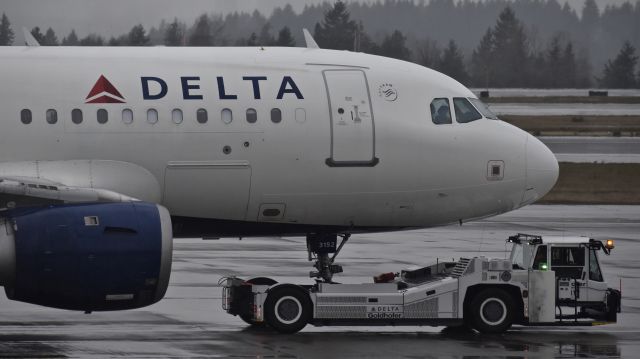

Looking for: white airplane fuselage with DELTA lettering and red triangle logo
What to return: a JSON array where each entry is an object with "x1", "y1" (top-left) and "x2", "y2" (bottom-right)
[{"x1": 0, "y1": 47, "x2": 558, "y2": 236}]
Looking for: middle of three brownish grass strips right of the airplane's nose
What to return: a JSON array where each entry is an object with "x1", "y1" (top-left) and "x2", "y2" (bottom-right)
[{"x1": 500, "y1": 115, "x2": 640, "y2": 136}]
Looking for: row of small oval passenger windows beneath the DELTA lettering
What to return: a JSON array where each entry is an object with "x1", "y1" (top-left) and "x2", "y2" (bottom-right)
[{"x1": 20, "y1": 108, "x2": 282, "y2": 125}]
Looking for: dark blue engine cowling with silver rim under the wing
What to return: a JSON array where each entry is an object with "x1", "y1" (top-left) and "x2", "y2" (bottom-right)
[{"x1": 0, "y1": 202, "x2": 173, "y2": 311}]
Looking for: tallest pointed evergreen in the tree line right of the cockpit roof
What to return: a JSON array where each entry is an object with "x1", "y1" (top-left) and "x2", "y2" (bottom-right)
[{"x1": 492, "y1": 6, "x2": 529, "y2": 87}]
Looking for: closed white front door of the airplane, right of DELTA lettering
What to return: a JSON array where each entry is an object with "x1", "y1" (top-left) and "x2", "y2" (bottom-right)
[{"x1": 323, "y1": 70, "x2": 378, "y2": 167}]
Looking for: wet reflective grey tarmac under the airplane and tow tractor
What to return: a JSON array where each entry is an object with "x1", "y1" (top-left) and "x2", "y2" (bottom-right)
[{"x1": 0, "y1": 205, "x2": 640, "y2": 358}]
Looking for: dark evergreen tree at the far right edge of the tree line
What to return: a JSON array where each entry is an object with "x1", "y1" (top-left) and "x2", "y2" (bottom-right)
[{"x1": 600, "y1": 41, "x2": 638, "y2": 89}]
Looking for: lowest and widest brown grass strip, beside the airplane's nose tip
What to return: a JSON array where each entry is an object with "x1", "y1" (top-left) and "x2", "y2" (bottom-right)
[{"x1": 539, "y1": 162, "x2": 640, "y2": 204}]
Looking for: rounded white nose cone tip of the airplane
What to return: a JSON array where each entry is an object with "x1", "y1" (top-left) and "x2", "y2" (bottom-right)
[{"x1": 522, "y1": 135, "x2": 558, "y2": 205}]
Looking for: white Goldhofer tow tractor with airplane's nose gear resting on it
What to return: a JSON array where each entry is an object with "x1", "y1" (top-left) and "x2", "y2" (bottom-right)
[{"x1": 221, "y1": 234, "x2": 621, "y2": 333}]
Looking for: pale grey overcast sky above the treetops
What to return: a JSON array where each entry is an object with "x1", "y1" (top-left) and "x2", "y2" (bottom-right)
[{"x1": 0, "y1": 0, "x2": 635, "y2": 43}]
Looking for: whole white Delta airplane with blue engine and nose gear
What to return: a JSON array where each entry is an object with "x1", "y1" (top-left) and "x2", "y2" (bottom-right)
[{"x1": 0, "y1": 33, "x2": 558, "y2": 311}]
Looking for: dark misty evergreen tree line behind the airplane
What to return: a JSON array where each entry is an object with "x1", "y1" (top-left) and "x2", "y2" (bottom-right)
[{"x1": 0, "y1": 0, "x2": 640, "y2": 88}]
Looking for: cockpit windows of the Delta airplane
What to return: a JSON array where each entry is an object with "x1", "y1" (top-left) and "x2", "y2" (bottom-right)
[{"x1": 430, "y1": 97, "x2": 498, "y2": 125}]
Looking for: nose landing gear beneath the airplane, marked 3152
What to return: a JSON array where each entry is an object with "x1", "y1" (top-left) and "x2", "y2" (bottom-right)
[{"x1": 307, "y1": 233, "x2": 351, "y2": 283}]
